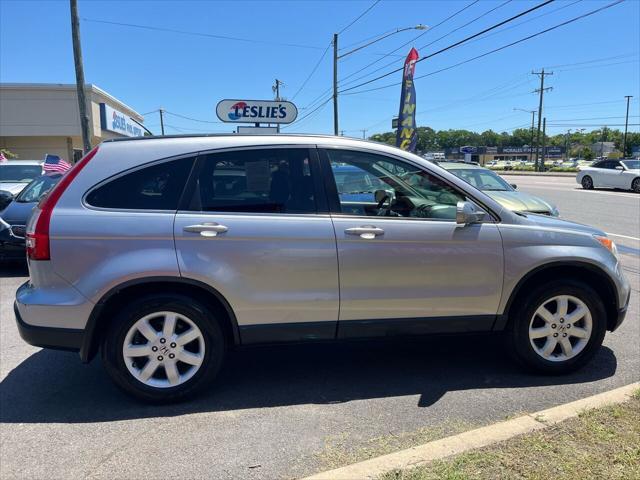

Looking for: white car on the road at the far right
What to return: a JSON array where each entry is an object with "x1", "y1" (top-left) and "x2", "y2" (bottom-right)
[{"x1": 576, "y1": 160, "x2": 640, "y2": 193}]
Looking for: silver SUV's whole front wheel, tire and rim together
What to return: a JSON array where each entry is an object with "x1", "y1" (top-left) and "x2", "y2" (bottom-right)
[{"x1": 508, "y1": 280, "x2": 606, "y2": 374}]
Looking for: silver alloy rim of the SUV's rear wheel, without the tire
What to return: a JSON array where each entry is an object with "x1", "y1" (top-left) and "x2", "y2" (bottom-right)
[{"x1": 122, "y1": 312, "x2": 205, "y2": 388}]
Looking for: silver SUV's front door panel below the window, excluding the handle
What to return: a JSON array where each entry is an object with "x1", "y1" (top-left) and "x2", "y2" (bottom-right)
[{"x1": 333, "y1": 216, "x2": 503, "y2": 321}]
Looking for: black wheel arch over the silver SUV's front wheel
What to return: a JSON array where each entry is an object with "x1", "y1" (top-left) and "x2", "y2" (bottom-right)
[{"x1": 493, "y1": 261, "x2": 618, "y2": 330}]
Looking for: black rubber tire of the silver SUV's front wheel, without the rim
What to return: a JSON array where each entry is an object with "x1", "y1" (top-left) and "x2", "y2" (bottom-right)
[{"x1": 506, "y1": 280, "x2": 607, "y2": 375}]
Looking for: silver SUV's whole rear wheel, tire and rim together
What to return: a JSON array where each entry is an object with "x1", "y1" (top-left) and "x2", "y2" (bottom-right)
[{"x1": 102, "y1": 295, "x2": 225, "y2": 403}]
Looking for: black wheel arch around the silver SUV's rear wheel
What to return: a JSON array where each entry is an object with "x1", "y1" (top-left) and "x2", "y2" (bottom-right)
[{"x1": 80, "y1": 277, "x2": 240, "y2": 363}]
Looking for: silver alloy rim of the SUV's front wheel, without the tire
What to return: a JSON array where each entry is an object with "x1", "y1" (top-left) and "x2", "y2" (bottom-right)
[{"x1": 529, "y1": 295, "x2": 593, "y2": 362}]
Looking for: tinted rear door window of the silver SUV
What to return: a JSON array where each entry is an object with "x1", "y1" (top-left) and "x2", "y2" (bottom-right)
[{"x1": 189, "y1": 148, "x2": 316, "y2": 213}]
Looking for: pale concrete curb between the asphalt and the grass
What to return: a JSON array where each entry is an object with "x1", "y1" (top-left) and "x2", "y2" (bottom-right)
[{"x1": 303, "y1": 382, "x2": 640, "y2": 480}]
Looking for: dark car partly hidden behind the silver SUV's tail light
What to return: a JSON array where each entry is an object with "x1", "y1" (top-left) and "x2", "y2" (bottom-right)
[{"x1": 0, "y1": 174, "x2": 62, "y2": 260}]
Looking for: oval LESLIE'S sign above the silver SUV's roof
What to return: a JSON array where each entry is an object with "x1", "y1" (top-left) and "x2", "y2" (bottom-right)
[{"x1": 216, "y1": 100, "x2": 298, "y2": 123}]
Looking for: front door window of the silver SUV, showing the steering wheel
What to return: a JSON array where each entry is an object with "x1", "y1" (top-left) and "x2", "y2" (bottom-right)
[{"x1": 326, "y1": 149, "x2": 465, "y2": 220}]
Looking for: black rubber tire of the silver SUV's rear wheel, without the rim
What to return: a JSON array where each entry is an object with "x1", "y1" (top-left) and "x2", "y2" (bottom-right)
[{"x1": 101, "y1": 294, "x2": 226, "y2": 403}]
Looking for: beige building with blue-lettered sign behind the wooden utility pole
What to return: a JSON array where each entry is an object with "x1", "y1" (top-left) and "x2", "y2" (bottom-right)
[{"x1": 0, "y1": 83, "x2": 144, "y2": 161}]
